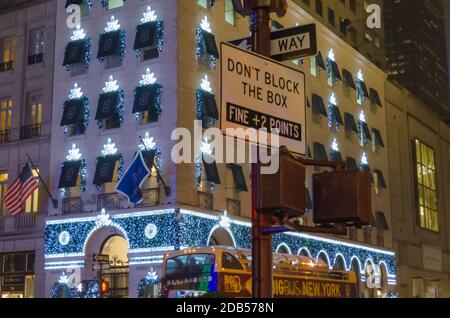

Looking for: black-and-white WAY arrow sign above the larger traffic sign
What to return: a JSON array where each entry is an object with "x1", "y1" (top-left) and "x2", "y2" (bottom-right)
[{"x1": 230, "y1": 24, "x2": 317, "y2": 61}]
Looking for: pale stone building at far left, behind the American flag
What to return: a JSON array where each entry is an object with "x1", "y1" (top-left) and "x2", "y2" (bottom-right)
[{"x1": 0, "y1": 1, "x2": 56, "y2": 298}]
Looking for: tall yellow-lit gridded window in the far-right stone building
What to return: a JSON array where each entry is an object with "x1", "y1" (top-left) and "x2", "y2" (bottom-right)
[{"x1": 413, "y1": 139, "x2": 439, "y2": 232}]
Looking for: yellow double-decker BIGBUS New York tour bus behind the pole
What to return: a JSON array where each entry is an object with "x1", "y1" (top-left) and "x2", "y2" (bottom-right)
[{"x1": 161, "y1": 247, "x2": 358, "y2": 298}]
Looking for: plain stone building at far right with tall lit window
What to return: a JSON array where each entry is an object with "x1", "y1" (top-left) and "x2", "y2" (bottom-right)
[{"x1": 386, "y1": 82, "x2": 450, "y2": 298}]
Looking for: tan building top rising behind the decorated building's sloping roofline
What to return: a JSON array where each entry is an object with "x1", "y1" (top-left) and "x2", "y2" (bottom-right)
[{"x1": 293, "y1": 0, "x2": 386, "y2": 70}]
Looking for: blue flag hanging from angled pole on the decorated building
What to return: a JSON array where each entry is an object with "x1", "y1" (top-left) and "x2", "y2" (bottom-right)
[{"x1": 116, "y1": 151, "x2": 150, "y2": 204}]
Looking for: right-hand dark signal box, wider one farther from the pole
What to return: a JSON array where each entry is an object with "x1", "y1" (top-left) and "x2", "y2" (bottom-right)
[{"x1": 313, "y1": 170, "x2": 372, "y2": 226}]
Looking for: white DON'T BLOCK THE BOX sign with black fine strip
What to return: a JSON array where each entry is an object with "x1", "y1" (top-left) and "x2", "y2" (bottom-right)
[{"x1": 221, "y1": 43, "x2": 306, "y2": 155}]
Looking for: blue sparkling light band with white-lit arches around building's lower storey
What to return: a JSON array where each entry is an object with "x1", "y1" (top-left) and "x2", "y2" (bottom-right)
[{"x1": 45, "y1": 209, "x2": 396, "y2": 285}]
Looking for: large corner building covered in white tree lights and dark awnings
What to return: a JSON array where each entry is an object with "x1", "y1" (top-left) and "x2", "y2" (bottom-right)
[{"x1": 41, "y1": 0, "x2": 396, "y2": 297}]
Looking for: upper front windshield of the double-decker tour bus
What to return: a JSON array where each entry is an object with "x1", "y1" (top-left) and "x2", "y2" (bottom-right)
[{"x1": 166, "y1": 254, "x2": 215, "y2": 278}]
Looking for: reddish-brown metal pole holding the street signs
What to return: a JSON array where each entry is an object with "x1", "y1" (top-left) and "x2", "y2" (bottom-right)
[{"x1": 250, "y1": 6, "x2": 272, "y2": 298}]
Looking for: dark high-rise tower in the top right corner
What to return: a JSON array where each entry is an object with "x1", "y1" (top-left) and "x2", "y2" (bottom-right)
[{"x1": 384, "y1": 0, "x2": 450, "y2": 120}]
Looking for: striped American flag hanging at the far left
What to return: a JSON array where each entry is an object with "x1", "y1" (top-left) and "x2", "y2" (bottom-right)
[{"x1": 3, "y1": 163, "x2": 39, "y2": 216}]
